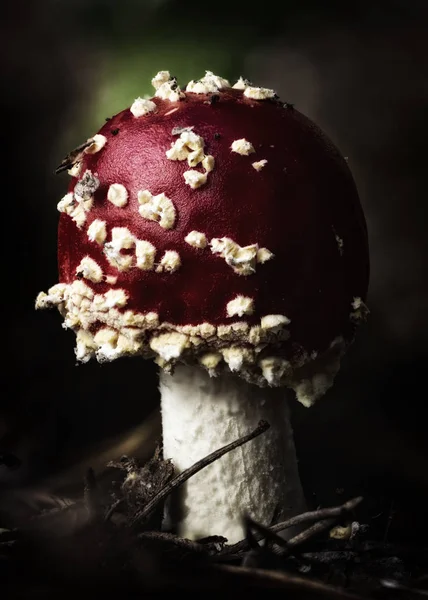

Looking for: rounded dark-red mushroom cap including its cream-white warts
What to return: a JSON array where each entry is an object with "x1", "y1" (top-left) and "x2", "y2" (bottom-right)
[{"x1": 38, "y1": 73, "x2": 369, "y2": 404}]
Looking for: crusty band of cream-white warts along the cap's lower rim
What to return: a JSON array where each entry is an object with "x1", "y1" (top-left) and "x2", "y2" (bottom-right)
[{"x1": 36, "y1": 280, "x2": 346, "y2": 396}]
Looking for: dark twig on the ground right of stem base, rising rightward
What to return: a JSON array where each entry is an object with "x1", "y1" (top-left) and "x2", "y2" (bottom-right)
[{"x1": 222, "y1": 496, "x2": 363, "y2": 554}]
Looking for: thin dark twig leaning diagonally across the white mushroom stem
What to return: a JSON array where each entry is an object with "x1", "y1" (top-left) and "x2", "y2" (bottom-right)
[{"x1": 129, "y1": 421, "x2": 270, "y2": 527}]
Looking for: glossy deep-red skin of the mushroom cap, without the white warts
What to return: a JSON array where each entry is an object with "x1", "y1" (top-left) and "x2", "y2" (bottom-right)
[{"x1": 58, "y1": 89, "x2": 369, "y2": 352}]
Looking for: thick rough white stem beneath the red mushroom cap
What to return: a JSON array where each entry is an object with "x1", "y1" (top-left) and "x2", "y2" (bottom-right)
[{"x1": 159, "y1": 366, "x2": 304, "y2": 543}]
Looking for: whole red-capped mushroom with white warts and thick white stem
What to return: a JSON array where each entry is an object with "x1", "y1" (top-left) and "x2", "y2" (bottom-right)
[{"x1": 36, "y1": 71, "x2": 369, "y2": 542}]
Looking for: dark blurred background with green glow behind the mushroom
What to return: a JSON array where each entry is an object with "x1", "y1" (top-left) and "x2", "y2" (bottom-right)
[{"x1": 0, "y1": 0, "x2": 428, "y2": 539}]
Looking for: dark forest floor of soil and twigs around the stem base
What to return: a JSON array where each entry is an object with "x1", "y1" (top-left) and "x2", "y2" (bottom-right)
[{"x1": 0, "y1": 423, "x2": 428, "y2": 600}]
